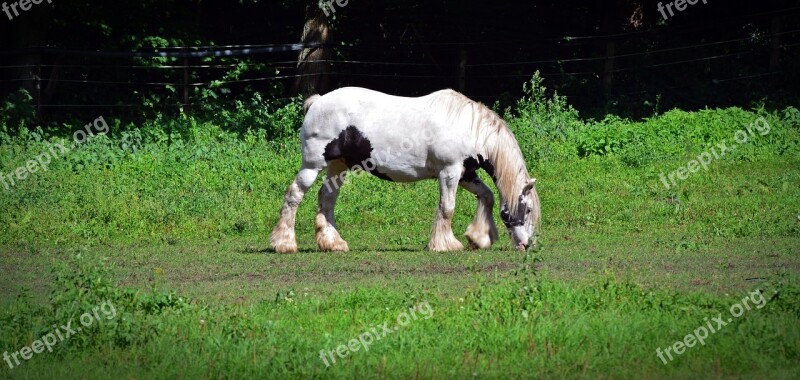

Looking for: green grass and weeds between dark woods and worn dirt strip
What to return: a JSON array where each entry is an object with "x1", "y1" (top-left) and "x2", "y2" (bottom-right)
[{"x1": 0, "y1": 77, "x2": 800, "y2": 244}]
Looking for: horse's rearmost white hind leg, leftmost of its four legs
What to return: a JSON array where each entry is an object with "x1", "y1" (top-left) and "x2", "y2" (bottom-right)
[{"x1": 270, "y1": 166, "x2": 321, "y2": 253}]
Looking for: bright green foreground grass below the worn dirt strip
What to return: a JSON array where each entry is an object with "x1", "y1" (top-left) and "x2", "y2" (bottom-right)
[{"x1": 0, "y1": 253, "x2": 800, "y2": 378}]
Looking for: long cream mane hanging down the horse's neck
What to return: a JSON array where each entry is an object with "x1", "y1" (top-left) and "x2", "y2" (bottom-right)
[{"x1": 430, "y1": 90, "x2": 528, "y2": 213}]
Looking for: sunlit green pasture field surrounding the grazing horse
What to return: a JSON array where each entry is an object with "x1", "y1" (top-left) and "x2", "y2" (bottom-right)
[{"x1": 0, "y1": 84, "x2": 800, "y2": 379}]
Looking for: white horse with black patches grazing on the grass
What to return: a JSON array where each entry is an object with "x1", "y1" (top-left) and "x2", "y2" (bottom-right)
[{"x1": 270, "y1": 87, "x2": 541, "y2": 253}]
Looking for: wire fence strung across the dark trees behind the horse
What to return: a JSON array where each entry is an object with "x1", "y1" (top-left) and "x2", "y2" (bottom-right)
[{"x1": 0, "y1": 7, "x2": 800, "y2": 114}]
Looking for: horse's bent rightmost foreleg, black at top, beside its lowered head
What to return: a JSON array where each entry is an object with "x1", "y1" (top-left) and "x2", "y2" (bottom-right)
[{"x1": 459, "y1": 178, "x2": 497, "y2": 249}]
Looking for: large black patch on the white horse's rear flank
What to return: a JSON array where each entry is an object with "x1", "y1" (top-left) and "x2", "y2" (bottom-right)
[{"x1": 322, "y1": 125, "x2": 392, "y2": 181}]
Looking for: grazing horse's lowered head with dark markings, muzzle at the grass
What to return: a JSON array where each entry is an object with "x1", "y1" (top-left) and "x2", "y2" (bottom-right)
[{"x1": 500, "y1": 178, "x2": 541, "y2": 250}]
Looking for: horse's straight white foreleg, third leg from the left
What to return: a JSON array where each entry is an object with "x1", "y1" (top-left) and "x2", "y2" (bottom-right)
[{"x1": 428, "y1": 167, "x2": 464, "y2": 251}]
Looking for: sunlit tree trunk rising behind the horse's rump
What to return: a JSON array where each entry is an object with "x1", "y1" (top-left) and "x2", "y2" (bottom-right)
[{"x1": 294, "y1": 0, "x2": 333, "y2": 97}]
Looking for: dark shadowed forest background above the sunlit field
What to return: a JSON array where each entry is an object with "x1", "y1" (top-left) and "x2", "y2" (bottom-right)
[{"x1": 0, "y1": 0, "x2": 800, "y2": 122}]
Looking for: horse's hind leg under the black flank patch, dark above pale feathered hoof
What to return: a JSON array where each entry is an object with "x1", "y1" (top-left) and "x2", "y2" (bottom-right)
[{"x1": 316, "y1": 161, "x2": 349, "y2": 252}]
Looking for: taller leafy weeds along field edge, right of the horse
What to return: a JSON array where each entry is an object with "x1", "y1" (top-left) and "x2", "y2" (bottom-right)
[{"x1": 506, "y1": 73, "x2": 799, "y2": 167}]
